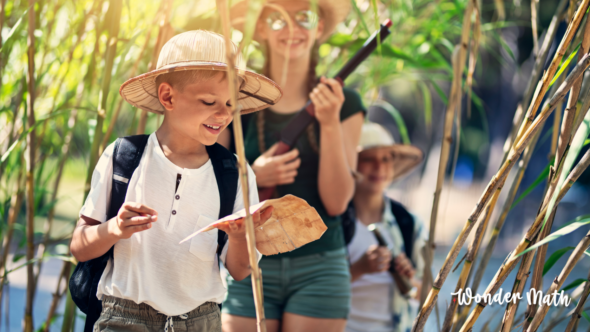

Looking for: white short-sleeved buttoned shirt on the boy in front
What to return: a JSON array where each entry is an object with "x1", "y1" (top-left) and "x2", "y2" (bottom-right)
[{"x1": 80, "y1": 133, "x2": 261, "y2": 316}]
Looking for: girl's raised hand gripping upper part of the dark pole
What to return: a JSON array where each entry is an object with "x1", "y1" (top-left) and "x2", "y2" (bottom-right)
[{"x1": 309, "y1": 76, "x2": 344, "y2": 125}]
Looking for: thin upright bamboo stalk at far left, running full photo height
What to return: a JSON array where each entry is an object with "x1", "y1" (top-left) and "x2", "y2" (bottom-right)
[{"x1": 24, "y1": 0, "x2": 36, "y2": 332}]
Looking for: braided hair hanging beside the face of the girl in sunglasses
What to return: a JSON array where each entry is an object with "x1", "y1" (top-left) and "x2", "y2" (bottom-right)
[{"x1": 256, "y1": 41, "x2": 320, "y2": 153}]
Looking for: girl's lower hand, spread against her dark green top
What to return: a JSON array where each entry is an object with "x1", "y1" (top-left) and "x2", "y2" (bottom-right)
[{"x1": 252, "y1": 143, "x2": 301, "y2": 188}]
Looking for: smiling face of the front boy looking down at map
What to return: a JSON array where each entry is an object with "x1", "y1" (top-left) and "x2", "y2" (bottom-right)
[{"x1": 158, "y1": 73, "x2": 237, "y2": 145}]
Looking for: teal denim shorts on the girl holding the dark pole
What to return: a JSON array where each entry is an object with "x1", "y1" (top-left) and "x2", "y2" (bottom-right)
[{"x1": 222, "y1": 248, "x2": 350, "y2": 319}]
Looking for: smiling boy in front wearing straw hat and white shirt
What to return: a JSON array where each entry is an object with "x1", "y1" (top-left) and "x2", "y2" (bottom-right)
[{"x1": 71, "y1": 31, "x2": 281, "y2": 331}]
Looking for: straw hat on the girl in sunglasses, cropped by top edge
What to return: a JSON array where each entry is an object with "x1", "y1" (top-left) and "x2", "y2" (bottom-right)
[{"x1": 229, "y1": 0, "x2": 351, "y2": 42}]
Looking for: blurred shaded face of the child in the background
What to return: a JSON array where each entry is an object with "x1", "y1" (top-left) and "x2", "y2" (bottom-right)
[{"x1": 357, "y1": 148, "x2": 396, "y2": 193}]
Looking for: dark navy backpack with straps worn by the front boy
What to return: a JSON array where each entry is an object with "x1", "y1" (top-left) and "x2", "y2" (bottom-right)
[{"x1": 69, "y1": 135, "x2": 238, "y2": 332}]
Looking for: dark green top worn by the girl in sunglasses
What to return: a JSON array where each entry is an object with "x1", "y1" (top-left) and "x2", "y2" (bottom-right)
[{"x1": 244, "y1": 88, "x2": 366, "y2": 258}]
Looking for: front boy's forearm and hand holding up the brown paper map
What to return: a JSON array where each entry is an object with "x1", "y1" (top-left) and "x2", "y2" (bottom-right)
[{"x1": 219, "y1": 207, "x2": 273, "y2": 281}]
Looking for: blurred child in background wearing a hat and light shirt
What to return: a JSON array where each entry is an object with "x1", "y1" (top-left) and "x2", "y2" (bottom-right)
[{"x1": 346, "y1": 123, "x2": 425, "y2": 332}]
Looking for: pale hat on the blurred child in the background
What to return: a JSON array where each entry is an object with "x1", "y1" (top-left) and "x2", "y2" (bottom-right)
[{"x1": 357, "y1": 122, "x2": 424, "y2": 180}]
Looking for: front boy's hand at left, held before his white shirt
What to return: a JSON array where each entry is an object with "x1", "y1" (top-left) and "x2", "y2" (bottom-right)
[{"x1": 108, "y1": 202, "x2": 158, "y2": 239}]
